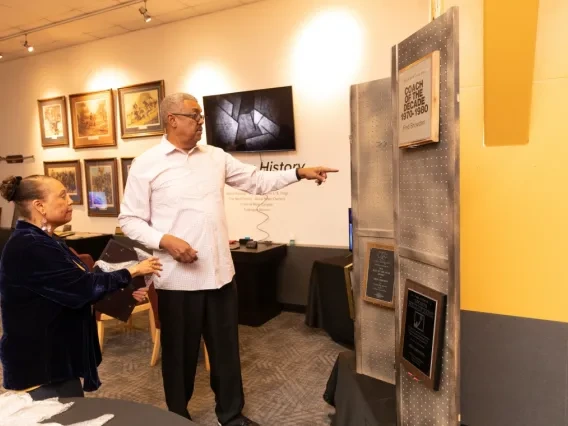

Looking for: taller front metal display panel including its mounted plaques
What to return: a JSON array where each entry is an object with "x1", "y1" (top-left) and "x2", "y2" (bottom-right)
[{"x1": 392, "y1": 7, "x2": 460, "y2": 426}]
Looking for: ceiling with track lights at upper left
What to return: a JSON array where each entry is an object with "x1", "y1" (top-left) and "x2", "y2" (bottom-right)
[{"x1": 0, "y1": 0, "x2": 261, "y2": 64}]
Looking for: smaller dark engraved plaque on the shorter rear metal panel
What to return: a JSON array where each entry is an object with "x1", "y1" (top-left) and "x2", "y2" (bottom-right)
[{"x1": 363, "y1": 243, "x2": 394, "y2": 309}]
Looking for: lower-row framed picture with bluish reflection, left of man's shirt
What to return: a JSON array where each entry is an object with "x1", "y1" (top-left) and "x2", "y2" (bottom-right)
[{"x1": 85, "y1": 158, "x2": 120, "y2": 217}]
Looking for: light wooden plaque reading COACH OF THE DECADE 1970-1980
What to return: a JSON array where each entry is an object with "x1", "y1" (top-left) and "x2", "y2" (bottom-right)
[{"x1": 398, "y1": 50, "x2": 440, "y2": 148}]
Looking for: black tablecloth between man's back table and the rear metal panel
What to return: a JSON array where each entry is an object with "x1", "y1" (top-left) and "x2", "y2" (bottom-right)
[{"x1": 306, "y1": 256, "x2": 355, "y2": 345}]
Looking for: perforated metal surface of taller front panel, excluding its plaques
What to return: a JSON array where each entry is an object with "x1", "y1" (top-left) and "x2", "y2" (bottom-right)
[{"x1": 392, "y1": 7, "x2": 459, "y2": 426}]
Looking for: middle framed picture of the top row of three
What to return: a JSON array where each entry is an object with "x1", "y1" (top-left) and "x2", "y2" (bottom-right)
[{"x1": 69, "y1": 89, "x2": 116, "y2": 148}]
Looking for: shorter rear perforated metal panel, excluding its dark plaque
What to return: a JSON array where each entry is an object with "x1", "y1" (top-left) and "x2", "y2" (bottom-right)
[{"x1": 351, "y1": 78, "x2": 395, "y2": 384}]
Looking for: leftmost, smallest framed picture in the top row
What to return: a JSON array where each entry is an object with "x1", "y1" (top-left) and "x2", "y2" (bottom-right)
[{"x1": 37, "y1": 96, "x2": 69, "y2": 148}]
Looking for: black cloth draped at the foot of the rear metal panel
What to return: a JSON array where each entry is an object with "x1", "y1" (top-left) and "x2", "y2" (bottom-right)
[{"x1": 323, "y1": 351, "x2": 397, "y2": 426}]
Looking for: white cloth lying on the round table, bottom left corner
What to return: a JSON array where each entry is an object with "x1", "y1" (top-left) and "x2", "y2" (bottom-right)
[{"x1": 0, "y1": 392, "x2": 114, "y2": 426}]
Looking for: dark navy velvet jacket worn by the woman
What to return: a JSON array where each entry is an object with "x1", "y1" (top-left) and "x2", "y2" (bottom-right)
[{"x1": 0, "y1": 221, "x2": 132, "y2": 392}]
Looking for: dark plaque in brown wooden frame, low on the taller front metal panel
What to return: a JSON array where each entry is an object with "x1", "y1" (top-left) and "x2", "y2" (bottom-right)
[{"x1": 400, "y1": 280, "x2": 446, "y2": 390}]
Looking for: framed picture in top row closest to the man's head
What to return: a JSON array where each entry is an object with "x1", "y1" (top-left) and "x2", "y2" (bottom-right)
[{"x1": 118, "y1": 80, "x2": 165, "y2": 139}]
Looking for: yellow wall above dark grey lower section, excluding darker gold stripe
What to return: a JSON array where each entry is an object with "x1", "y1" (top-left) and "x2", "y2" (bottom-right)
[{"x1": 452, "y1": 0, "x2": 568, "y2": 322}]
